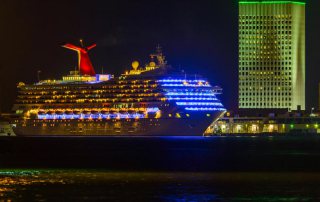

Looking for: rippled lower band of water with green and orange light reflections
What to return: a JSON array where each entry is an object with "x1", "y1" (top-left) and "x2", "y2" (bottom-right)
[{"x1": 0, "y1": 170, "x2": 320, "y2": 202}]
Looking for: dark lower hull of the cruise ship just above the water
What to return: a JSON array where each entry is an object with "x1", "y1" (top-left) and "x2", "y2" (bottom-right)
[{"x1": 14, "y1": 113, "x2": 221, "y2": 136}]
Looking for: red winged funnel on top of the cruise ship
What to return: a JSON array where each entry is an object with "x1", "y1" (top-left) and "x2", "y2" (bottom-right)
[{"x1": 62, "y1": 40, "x2": 96, "y2": 76}]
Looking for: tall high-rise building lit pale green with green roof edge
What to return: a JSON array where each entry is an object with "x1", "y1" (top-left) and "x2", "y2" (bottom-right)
[{"x1": 239, "y1": 0, "x2": 306, "y2": 110}]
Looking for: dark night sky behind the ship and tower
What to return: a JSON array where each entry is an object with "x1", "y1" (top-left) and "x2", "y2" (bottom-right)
[{"x1": 0, "y1": 0, "x2": 320, "y2": 112}]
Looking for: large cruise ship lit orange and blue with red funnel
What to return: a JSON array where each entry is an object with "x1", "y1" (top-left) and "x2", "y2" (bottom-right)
[{"x1": 12, "y1": 43, "x2": 226, "y2": 136}]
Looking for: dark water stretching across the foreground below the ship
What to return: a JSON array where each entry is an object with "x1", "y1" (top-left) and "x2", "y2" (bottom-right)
[{"x1": 0, "y1": 137, "x2": 320, "y2": 202}]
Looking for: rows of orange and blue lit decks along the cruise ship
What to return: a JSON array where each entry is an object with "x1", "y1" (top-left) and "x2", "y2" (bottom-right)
[{"x1": 17, "y1": 79, "x2": 225, "y2": 119}]
